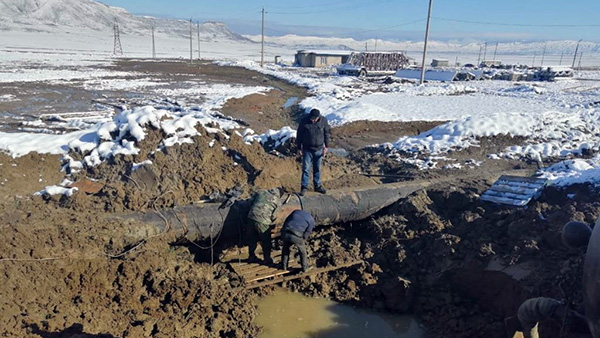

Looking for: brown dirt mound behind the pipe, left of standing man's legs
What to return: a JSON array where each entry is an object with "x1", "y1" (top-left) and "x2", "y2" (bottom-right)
[{"x1": 49, "y1": 123, "x2": 372, "y2": 212}]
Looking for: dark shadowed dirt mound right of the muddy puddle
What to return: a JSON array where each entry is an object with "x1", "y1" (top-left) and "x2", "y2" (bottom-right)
[{"x1": 284, "y1": 183, "x2": 600, "y2": 338}]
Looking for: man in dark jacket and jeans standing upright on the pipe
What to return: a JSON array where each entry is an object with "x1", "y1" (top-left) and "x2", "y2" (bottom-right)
[{"x1": 296, "y1": 109, "x2": 331, "y2": 196}]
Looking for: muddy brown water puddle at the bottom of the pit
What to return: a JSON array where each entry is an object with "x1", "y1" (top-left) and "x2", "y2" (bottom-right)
[{"x1": 257, "y1": 289, "x2": 425, "y2": 338}]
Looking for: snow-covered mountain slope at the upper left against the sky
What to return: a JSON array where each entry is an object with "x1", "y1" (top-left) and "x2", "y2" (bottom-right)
[{"x1": 0, "y1": 0, "x2": 248, "y2": 42}]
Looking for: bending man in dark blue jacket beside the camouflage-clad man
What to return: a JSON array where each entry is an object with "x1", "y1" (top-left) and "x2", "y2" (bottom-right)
[{"x1": 281, "y1": 210, "x2": 315, "y2": 272}]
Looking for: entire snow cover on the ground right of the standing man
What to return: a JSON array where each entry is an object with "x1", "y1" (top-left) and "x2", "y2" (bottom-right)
[{"x1": 226, "y1": 62, "x2": 600, "y2": 184}]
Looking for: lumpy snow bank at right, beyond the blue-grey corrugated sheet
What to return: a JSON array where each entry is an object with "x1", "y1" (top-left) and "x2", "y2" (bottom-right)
[{"x1": 385, "y1": 110, "x2": 600, "y2": 161}]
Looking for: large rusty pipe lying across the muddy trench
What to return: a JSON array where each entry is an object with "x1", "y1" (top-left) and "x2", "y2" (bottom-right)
[{"x1": 109, "y1": 181, "x2": 431, "y2": 239}]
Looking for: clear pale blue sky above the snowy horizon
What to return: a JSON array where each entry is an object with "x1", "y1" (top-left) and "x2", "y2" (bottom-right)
[{"x1": 101, "y1": 0, "x2": 600, "y2": 42}]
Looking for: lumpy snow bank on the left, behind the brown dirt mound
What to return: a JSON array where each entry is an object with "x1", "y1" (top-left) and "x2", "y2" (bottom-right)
[{"x1": 0, "y1": 85, "x2": 270, "y2": 174}]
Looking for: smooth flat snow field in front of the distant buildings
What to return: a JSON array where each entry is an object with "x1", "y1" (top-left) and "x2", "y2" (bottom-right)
[{"x1": 226, "y1": 61, "x2": 600, "y2": 125}]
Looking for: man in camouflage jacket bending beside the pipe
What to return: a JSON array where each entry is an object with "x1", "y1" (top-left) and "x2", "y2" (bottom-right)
[{"x1": 246, "y1": 188, "x2": 282, "y2": 265}]
